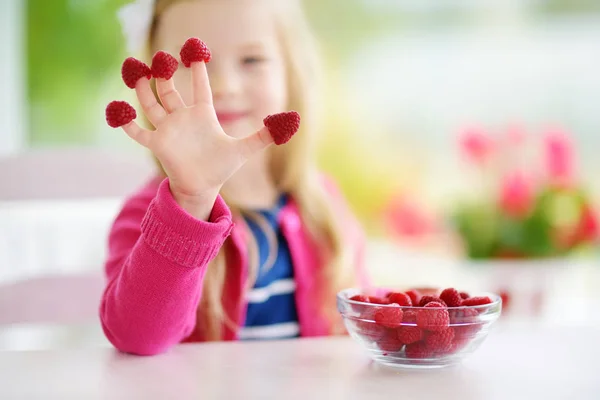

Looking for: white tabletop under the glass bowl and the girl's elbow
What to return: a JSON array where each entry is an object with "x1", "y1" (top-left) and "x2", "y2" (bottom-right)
[{"x1": 0, "y1": 327, "x2": 600, "y2": 400}]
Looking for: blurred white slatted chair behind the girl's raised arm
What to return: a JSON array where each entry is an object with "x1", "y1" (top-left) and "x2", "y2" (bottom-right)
[{"x1": 0, "y1": 148, "x2": 154, "y2": 350}]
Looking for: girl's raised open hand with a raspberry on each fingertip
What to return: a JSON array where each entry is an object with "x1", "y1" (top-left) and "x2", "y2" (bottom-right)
[{"x1": 106, "y1": 38, "x2": 300, "y2": 219}]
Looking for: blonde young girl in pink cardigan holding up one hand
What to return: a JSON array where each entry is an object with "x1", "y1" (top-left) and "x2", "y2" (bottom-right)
[{"x1": 100, "y1": 0, "x2": 366, "y2": 355}]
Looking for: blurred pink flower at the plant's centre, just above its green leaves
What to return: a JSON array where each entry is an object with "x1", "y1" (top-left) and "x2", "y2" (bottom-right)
[{"x1": 499, "y1": 171, "x2": 534, "y2": 218}]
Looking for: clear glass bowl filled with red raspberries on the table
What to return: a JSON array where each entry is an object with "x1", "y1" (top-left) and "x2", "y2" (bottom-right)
[{"x1": 337, "y1": 288, "x2": 502, "y2": 368}]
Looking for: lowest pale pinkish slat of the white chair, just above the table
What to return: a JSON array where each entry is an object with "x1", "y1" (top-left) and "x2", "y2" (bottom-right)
[{"x1": 0, "y1": 272, "x2": 110, "y2": 352}]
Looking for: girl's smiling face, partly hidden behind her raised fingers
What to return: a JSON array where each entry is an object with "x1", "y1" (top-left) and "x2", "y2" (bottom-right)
[{"x1": 154, "y1": 0, "x2": 288, "y2": 138}]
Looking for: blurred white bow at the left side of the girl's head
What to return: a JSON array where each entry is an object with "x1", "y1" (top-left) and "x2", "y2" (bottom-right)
[{"x1": 117, "y1": 0, "x2": 156, "y2": 54}]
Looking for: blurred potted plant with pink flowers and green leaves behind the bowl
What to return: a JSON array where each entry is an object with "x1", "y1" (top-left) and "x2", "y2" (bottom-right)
[{"x1": 451, "y1": 129, "x2": 600, "y2": 315}]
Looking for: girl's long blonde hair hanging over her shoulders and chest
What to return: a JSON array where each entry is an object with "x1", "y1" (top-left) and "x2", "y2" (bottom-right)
[{"x1": 148, "y1": 0, "x2": 353, "y2": 340}]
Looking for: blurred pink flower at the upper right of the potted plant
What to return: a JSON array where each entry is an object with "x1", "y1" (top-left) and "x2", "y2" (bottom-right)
[{"x1": 545, "y1": 130, "x2": 574, "y2": 187}]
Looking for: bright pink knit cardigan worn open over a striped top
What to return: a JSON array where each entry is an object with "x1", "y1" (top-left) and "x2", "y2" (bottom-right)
[{"x1": 100, "y1": 178, "x2": 367, "y2": 355}]
